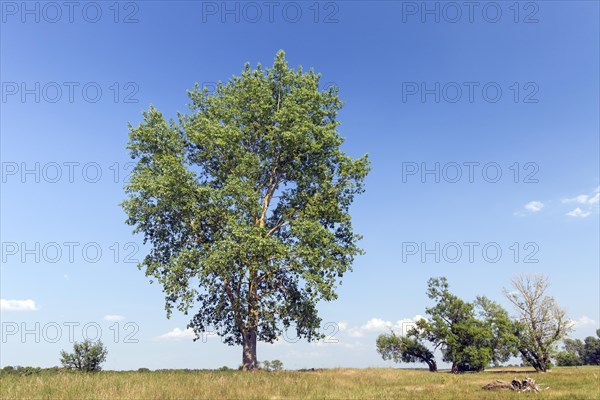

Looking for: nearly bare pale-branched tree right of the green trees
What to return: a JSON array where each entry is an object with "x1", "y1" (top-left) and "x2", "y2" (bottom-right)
[{"x1": 504, "y1": 275, "x2": 572, "y2": 372}]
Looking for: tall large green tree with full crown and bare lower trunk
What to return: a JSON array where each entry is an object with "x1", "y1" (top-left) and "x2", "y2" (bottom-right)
[{"x1": 123, "y1": 51, "x2": 369, "y2": 369}]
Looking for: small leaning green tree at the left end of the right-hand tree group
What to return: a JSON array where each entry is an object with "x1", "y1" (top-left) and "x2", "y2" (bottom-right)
[{"x1": 377, "y1": 332, "x2": 437, "y2": 372}]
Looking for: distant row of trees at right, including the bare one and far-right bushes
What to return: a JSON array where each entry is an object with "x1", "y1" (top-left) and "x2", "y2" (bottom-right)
[{"x1": 377, "y1": 276, "x2": 576, "y2": 373}]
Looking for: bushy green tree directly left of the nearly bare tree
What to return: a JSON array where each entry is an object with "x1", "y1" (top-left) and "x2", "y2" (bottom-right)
[{"x1": 411, "y1": 277, "x2": 516, "y2": 372}]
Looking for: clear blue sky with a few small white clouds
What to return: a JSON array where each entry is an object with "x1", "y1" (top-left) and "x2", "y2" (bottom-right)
[{"x1": 0, "y1": 1, "x2": 600, "y2": 369}]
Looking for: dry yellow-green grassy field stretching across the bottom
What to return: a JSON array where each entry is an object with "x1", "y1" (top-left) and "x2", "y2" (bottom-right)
[{"x1": 0, "y1": 367, "x2": 600, "y2": 400}]
